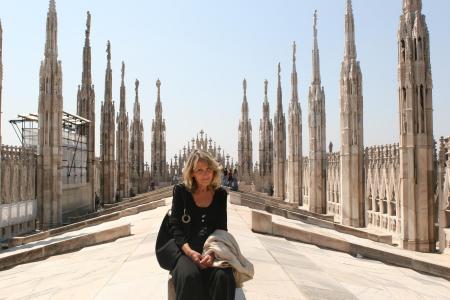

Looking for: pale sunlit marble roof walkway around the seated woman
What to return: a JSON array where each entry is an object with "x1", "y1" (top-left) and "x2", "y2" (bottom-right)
[{"x1": 0, "y1": 198, "x2": 450, "y2": 300}]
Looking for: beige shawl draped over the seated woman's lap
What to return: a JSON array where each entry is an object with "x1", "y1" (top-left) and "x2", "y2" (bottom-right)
[{"x1": 203, "y1": 229, "x2": 255, "y2": 287}]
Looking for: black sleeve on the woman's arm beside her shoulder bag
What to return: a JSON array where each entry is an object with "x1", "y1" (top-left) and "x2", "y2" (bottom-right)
[{"x1": 169, "y1": 185, "x2": 188, "y2": 248}]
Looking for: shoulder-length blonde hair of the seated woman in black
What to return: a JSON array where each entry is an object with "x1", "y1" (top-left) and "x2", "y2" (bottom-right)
[{"x1": 183, "y1": 149, "x2": 221, "y2": 193}]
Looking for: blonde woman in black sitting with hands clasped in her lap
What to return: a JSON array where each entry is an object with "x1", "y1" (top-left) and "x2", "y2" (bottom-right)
[{"x1": 169, "y1": 150, "x2": 236, "y2": 300}]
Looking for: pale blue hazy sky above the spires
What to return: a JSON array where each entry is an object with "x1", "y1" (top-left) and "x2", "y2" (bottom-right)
[{"x1": 0, "y1": 0, "x2": 450, "y2": 161}]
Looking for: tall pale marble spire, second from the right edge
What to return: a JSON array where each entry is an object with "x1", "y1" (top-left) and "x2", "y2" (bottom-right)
[{"x1": 339, "y1": 0, "x2": 365, "y2": 227}]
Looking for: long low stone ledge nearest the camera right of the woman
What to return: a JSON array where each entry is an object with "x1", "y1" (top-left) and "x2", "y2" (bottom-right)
[{"x1": 252, "y1": 210, "x2": 450, "y2": 280}]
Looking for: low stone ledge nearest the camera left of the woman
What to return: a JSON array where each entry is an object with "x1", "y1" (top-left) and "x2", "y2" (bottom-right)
[{"x1": 0, "y1": 224, "x2": 131, "y2": 270}]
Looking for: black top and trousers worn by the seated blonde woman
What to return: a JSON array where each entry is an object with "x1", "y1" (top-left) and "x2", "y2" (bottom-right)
[{"x1": 169, "y1": 184, "x2": 236, "y2": 300}]
